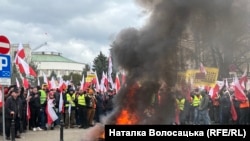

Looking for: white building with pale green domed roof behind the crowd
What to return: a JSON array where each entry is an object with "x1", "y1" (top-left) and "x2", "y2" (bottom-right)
[{"x1": 12, "y1": 43, "x2": 85, "y2": 77}]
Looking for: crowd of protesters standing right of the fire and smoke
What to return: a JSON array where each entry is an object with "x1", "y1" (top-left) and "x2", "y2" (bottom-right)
[{"x1": 174, "y1": 86, "x2": 250, "y2": 125}]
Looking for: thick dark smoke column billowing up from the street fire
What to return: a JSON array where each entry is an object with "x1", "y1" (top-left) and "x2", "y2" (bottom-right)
[{"x1": 82, "y1": 0, "x2": 246, "y2": 140}]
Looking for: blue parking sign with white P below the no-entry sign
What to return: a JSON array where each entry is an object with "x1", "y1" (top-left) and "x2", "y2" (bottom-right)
[{"x1": 0, "y1": 55, "x2": 11, "y2": 78}]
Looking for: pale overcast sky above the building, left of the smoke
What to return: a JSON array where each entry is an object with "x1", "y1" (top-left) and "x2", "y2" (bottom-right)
[{"x1": 0, "y1": 0, "x2": 146, "y2": 64}]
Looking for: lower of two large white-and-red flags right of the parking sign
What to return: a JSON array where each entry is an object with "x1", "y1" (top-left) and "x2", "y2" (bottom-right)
[{"x1": 17, "y1": 57, "x2": 37, "y2": 77}]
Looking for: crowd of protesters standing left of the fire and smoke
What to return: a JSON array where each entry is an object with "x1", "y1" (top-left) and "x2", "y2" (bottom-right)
[{"x1": 0, "y1": 84, "x2": 116, "y2": 140}]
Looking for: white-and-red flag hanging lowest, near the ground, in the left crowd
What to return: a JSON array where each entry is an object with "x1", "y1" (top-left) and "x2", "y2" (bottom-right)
[{"x1": 46, "y1": 98, "x2": 58, "y2": 125}]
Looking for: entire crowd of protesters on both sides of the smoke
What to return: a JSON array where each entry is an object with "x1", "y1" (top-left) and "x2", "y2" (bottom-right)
[{"x1": 0, "y1": 80, "x2": 250, "y2": 140}]
